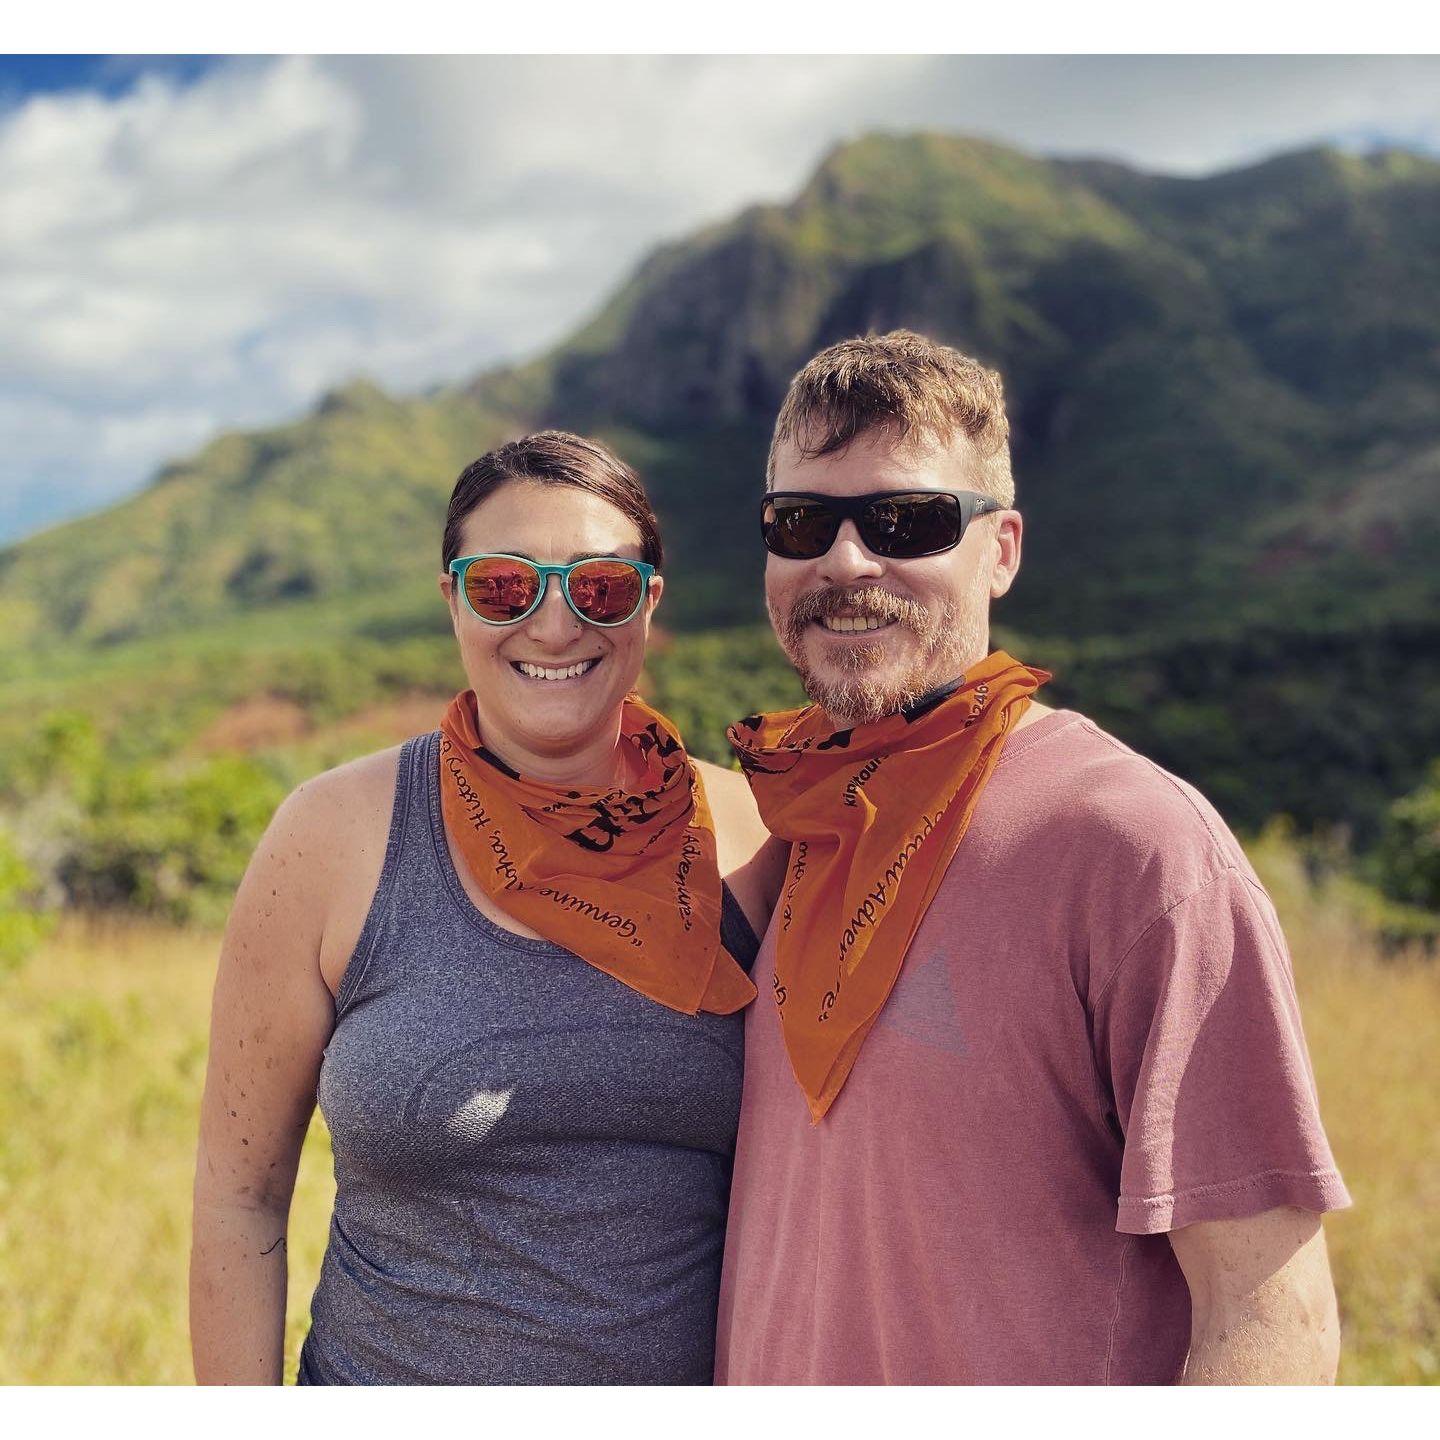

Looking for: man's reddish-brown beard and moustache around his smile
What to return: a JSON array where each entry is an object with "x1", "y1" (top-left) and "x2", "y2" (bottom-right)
[{"x1": 766, "y1": 576, "x2": 989, "y2": 727}]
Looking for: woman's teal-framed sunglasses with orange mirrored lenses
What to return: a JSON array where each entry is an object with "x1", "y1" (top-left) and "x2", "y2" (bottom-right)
[{"x1": 449, "y1": 554, "x2": 655, "y2": 625}]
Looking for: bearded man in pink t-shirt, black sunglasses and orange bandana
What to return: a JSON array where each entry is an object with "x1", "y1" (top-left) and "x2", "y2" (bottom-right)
[{"x1": 717, "y1": 331, "x2": 1349, "y2": 1384}]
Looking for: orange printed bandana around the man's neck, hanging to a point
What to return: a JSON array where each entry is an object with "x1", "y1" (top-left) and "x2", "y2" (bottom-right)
[{"x1": 729, "y1": 651, "x2": 1050, "y2": 1123}]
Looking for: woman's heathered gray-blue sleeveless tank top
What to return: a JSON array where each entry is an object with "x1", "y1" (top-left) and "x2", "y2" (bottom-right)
[{"x1": 300, "y1": 733, "x2": 757, "y2": 1385}]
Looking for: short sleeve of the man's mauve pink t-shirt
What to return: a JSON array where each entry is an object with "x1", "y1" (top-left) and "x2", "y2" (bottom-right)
[{"x1": 1093, "y1": 868, "x2": 1349, "y2": 1236}]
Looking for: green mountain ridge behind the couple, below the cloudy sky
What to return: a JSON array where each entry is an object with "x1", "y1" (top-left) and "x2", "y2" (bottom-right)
[{"x1": 0, "y1": 134, "x2": 1440, "y2": 828}]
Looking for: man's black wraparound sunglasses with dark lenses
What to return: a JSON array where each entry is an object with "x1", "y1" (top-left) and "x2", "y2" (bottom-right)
[{"x1": 760, "y1": 490, "x2": 1008, "y2": 560}]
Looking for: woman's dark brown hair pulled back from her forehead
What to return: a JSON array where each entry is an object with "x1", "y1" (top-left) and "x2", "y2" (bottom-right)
[{"x1": 441, "y1": 431, "x2": 664, "y2": 570}]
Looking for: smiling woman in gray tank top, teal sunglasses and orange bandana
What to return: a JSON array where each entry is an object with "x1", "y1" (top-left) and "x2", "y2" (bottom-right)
[{"x1": 190, "y1": 432, "x2": 779, "y2": 1384}]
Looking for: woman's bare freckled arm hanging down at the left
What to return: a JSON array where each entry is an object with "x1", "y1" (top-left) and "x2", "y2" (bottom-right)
[{"x1": 190, "y1": 782, "x2": 334, "y2": 1385}]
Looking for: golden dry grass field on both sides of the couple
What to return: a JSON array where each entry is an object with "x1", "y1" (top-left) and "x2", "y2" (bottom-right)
[{"x1": 0, "y1": 840, "x2": 1440, "y2": 1384}]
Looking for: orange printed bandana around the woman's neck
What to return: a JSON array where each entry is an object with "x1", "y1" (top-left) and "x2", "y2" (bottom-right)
[{"x1": 441, "y1": 690, "x2": 755, "y2": 1015}]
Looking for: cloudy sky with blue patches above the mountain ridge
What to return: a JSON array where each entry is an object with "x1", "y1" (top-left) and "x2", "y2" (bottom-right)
[{"x1": 0, "y1": 56, "x2": 1440, "y2": 546}]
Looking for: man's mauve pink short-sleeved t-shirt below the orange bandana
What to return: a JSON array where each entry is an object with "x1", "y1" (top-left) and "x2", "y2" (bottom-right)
[{"x1": 716, "y1": 711, "x2": 1349, "y2": 1385}]
